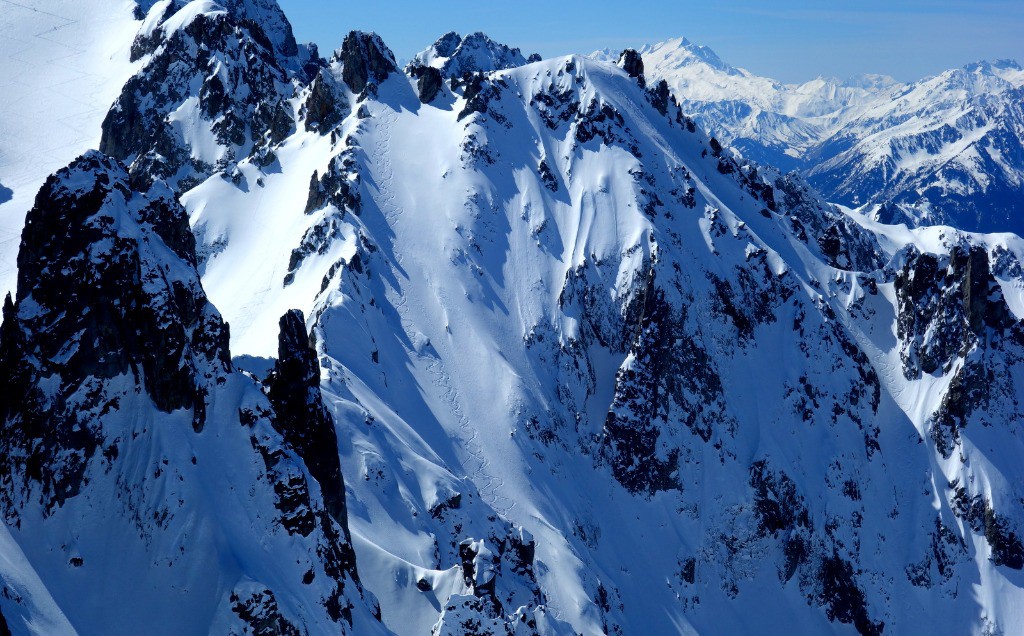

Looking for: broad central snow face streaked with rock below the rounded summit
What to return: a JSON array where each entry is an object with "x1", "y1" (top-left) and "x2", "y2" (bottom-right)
[{"x1": 301, "y1": 55, "x2": 1019, "y2": 633}]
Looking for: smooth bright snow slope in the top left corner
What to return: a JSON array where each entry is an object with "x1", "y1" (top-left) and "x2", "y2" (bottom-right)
[{"x1": 0, "y1": 0, "x2": 138, "y2": 293}]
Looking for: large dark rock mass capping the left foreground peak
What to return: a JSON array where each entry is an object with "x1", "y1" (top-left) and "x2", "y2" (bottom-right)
[{"x1": 0, "y1": 152, "x2": 230, "y2": 510}]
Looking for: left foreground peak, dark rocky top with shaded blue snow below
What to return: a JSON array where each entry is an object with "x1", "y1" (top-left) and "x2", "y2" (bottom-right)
[{"x1": 0, "y1": 153, "x2": 379, "y2": 633}]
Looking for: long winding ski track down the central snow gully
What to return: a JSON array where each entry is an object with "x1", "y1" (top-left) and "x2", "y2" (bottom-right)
[{"x1": 374, "y1": 110, "x2": 515, "y2": 518}]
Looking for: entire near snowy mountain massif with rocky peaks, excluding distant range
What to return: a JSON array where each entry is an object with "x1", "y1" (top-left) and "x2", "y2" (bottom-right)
[{"x1": 6, "y1": 0, "x2": 1024, "y2": 636}]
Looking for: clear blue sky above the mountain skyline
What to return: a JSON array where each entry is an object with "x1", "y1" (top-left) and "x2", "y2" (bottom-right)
[{"x1": 279, "y1": 0, "x2": 1024, "y2": 82}]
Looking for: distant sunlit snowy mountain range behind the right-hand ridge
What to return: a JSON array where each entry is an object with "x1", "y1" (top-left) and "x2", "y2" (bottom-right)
[{"x1": 606, "y1": 39, "x2": 1024, "y2": 234}]
